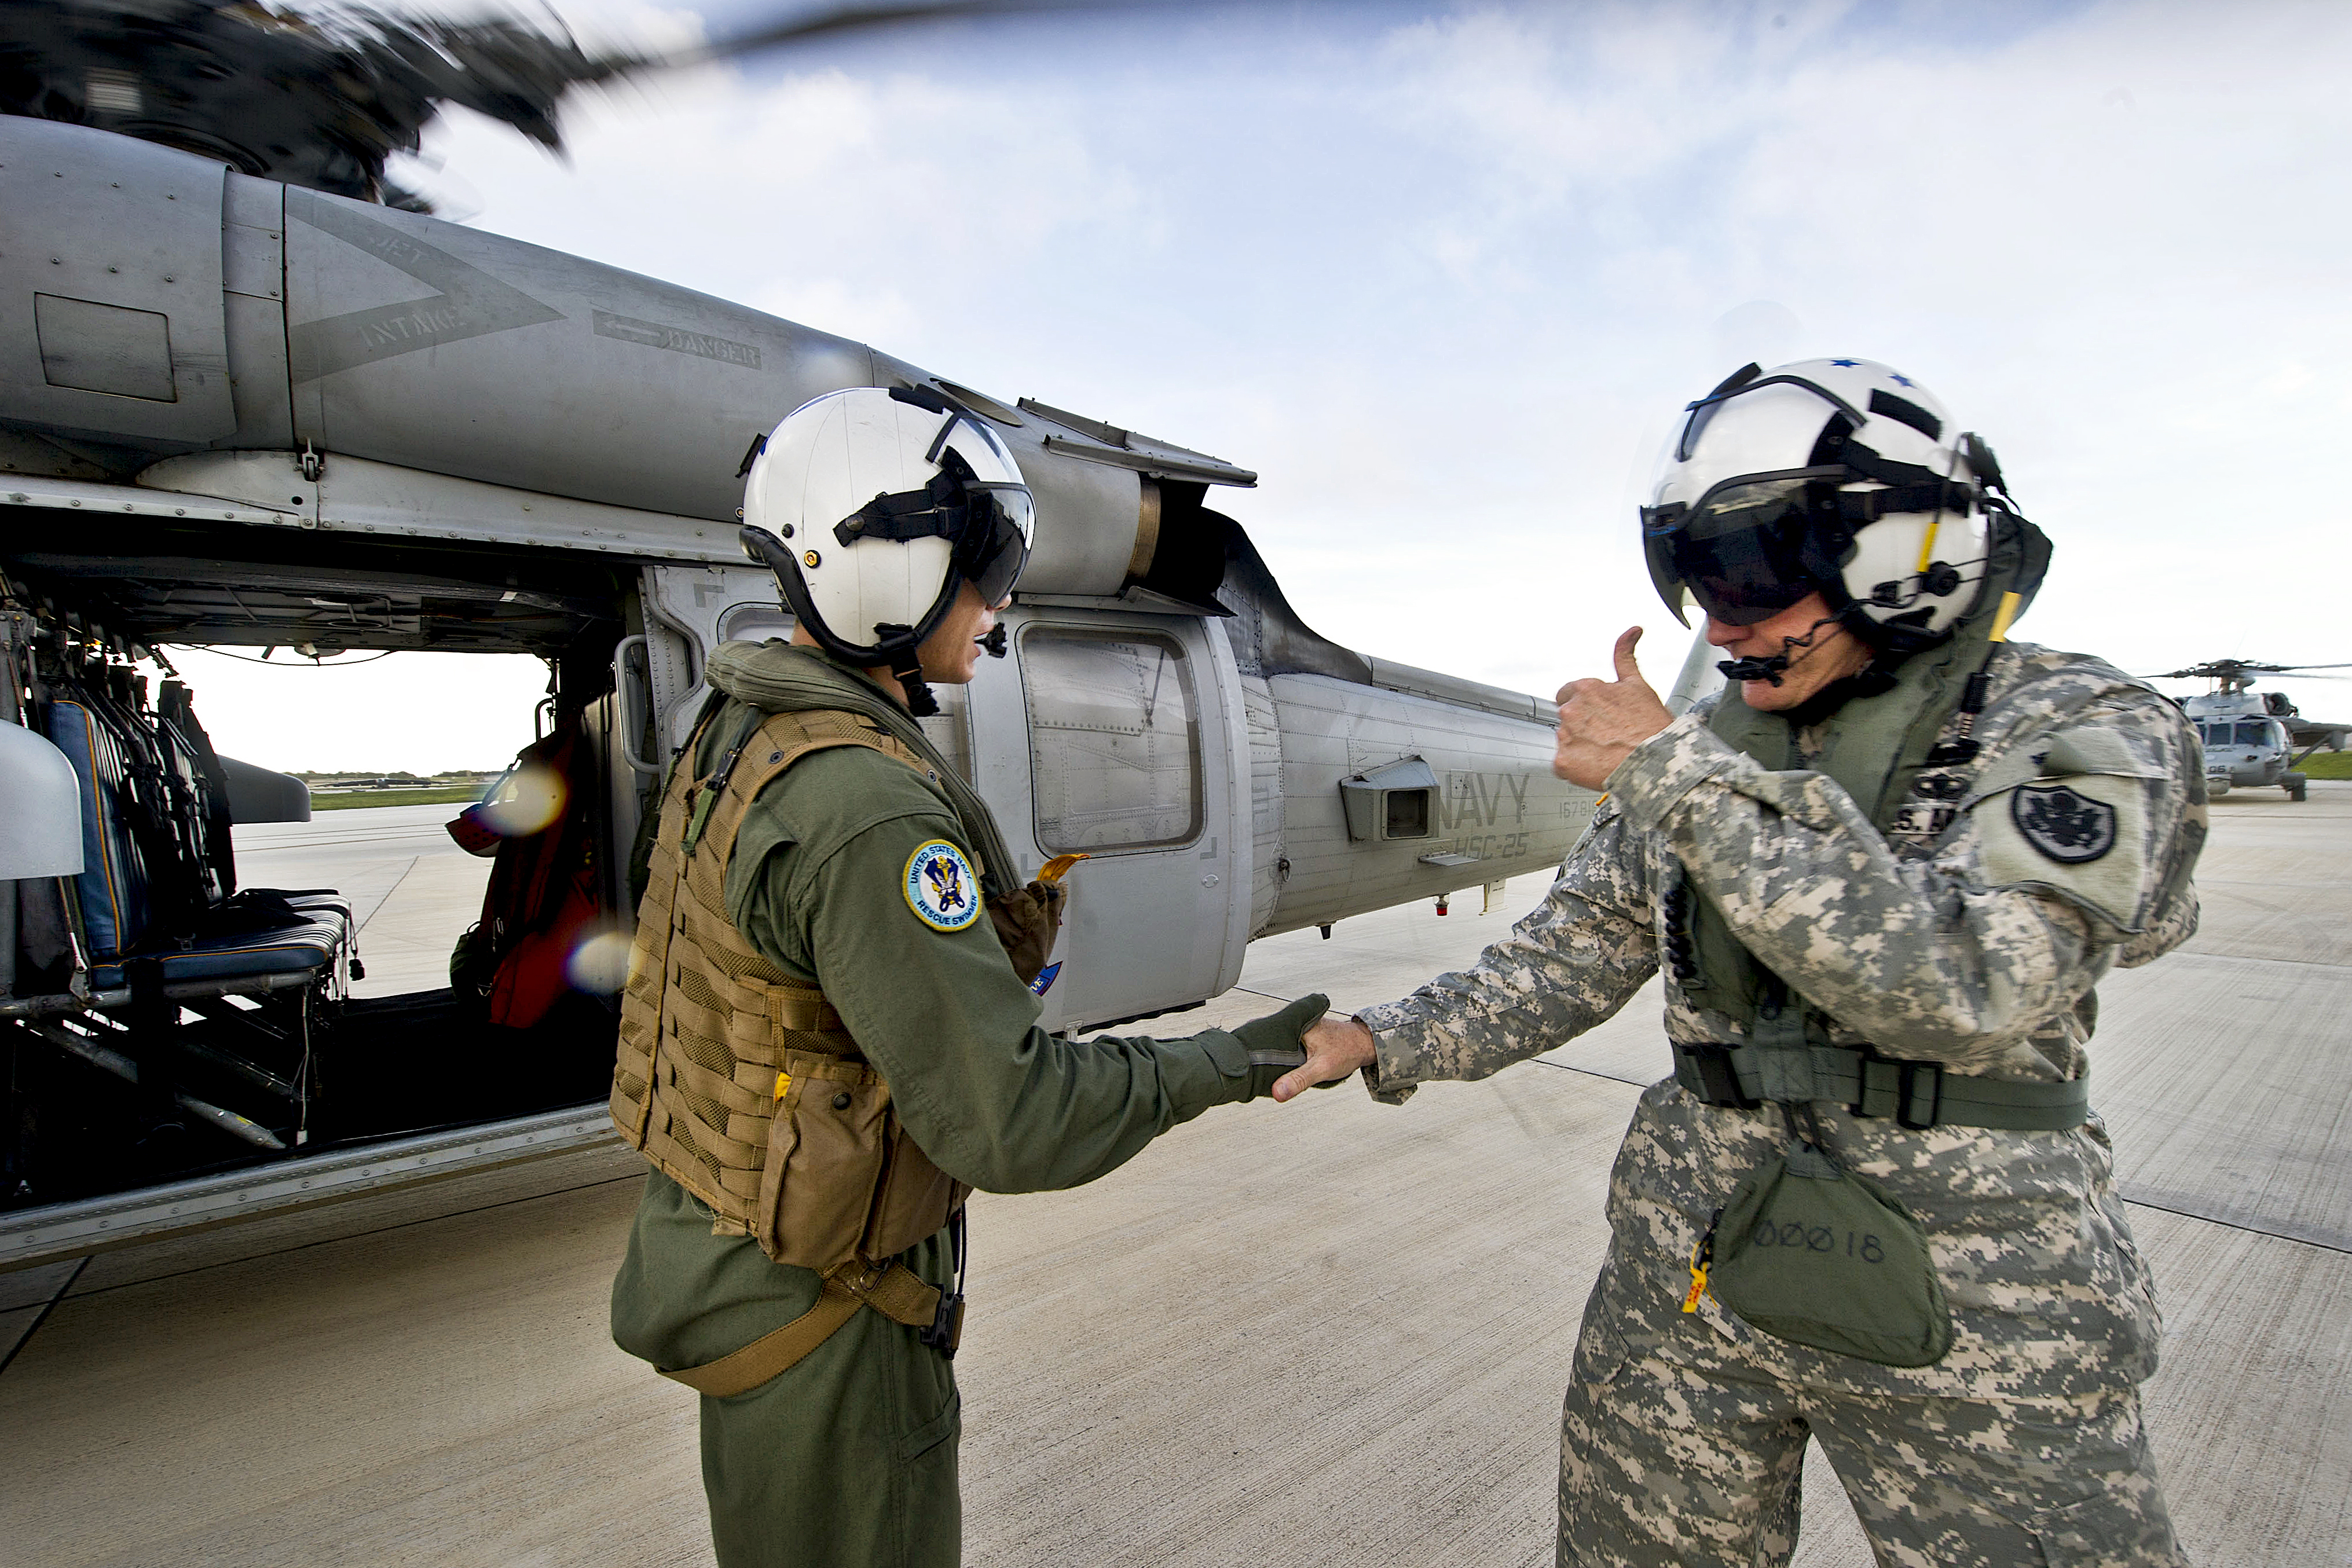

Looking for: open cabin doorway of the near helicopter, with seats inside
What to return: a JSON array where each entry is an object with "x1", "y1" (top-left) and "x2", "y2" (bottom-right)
[{"x1": 0, "y1": 532, "x2": 642, "y2": 1213}]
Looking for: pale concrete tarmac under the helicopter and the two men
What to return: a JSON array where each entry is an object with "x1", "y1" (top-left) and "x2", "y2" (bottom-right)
[{"x1": 0, "y1": 783, "x2": 2352, "y2": 1568}]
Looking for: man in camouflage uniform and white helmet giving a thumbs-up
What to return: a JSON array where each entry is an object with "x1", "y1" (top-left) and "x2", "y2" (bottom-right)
[{"x1": 1275, "y1": 360, "x2": 2204, "y2": 1568}]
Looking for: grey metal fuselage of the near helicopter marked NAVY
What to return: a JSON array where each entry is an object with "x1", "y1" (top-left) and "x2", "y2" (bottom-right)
[{"x1": 0, "y1": 118, "x2": 1595, "y2": 1265}]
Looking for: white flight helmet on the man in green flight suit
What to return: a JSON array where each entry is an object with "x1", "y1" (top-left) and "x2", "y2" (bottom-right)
[{"x1": 743, "y1": 386, "x2": 1035, "y2": 715}]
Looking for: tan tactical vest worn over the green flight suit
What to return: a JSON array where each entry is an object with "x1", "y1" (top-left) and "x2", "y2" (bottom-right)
[{"x1": 611, "y1": 712, "x2": 969, "y2": 1274}]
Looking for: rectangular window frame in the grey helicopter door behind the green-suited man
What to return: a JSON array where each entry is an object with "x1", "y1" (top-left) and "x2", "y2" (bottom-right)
[{"x1": 1016, "y1": 621, "x2": 1209, "y2": 856}]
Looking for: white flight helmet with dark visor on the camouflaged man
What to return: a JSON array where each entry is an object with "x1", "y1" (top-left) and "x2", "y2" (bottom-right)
[{"x1": 1642, "y1": 360, "x2": 2009, "y2": 654}]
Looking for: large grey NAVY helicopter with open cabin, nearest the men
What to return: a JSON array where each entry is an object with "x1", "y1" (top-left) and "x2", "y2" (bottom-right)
[{"x1": 0, "y1": 0, "x2": 1595, "y2": 1267}]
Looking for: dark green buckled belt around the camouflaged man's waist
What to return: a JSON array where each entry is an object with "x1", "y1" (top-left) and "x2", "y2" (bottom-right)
[{"x1": 1675, "y1": 1042, "x2": 2091, "y2": 1133}]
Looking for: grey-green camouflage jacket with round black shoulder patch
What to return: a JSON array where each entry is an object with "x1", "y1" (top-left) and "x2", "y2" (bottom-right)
[{"x1": 1360, "y1": 644, "x2": 2204, "y2": 1397}]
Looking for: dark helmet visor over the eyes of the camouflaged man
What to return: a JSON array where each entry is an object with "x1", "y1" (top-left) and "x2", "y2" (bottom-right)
[{"x1": 1642, "y1": 470, "x2": 1839, "y2": 625}]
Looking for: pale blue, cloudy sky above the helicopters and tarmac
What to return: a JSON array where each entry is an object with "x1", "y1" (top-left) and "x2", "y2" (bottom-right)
[{"x1": 184, "y1": 0, "x2": 2352, "y2": 771}]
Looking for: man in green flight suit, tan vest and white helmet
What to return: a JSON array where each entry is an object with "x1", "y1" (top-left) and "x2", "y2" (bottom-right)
[{"x1": 611, "y1": 388, "x2": 1324, "y2": 1568}]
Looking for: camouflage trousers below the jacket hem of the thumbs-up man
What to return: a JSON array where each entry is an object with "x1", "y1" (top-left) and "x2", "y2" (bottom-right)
[{"x1": 1559, "y1": 1354, "x2": 2188, "y2": 1568}]
